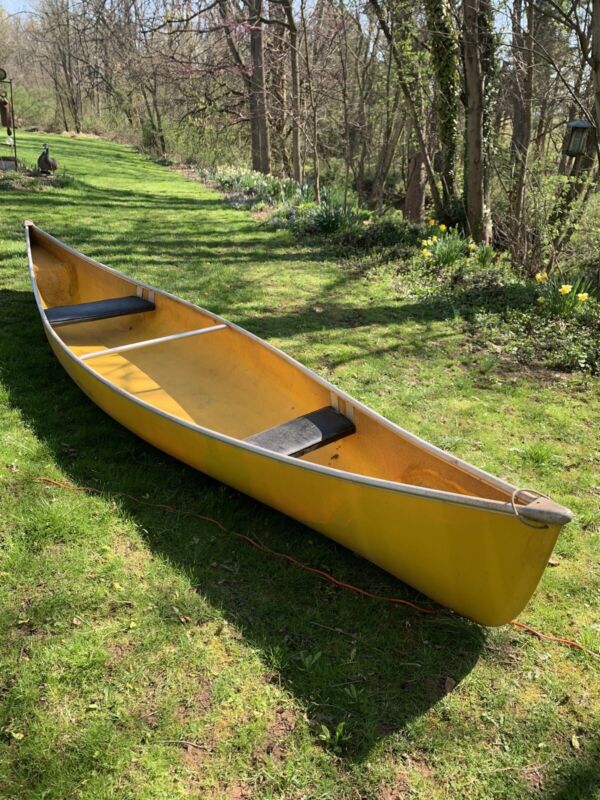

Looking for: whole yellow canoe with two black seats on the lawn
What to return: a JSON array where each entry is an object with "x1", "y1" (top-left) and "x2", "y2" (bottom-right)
[{"x1": 25, "y1": 221, "x2": 572, "y2": 625}]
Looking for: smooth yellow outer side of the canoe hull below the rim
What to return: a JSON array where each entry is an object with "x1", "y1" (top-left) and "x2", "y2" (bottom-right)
[{"x1": 46, "y1": 334, "x2": 560, "y2": 626}]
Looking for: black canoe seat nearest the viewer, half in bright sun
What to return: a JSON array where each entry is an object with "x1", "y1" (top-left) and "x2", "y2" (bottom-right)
[{"x1": 246, "y1": 406, "x2": 356, "y2": 456}]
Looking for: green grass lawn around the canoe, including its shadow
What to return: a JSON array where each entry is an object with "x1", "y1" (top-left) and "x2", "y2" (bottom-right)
[{"x1": 0, "y1": 135, "x2": 600, "y2": 800}]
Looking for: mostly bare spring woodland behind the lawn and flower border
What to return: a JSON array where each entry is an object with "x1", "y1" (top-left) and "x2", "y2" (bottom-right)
[{"x1": 0, "y1": 0, "x2": 600, "y2": 277}]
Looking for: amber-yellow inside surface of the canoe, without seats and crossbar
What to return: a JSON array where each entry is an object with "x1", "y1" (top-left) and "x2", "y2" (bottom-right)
[{"x1": 30, "y1": 228, "x2": 510, "y2": 501}]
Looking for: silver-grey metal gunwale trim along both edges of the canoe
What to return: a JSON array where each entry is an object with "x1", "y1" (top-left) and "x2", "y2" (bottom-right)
[{"x1": 23, "y1": 220, "x2": 572, "y2": 523}]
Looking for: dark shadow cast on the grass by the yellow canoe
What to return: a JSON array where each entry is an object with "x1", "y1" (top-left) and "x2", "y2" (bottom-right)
[{"x1": 0, "y1": 291, "x2": 485, "y2": 761}]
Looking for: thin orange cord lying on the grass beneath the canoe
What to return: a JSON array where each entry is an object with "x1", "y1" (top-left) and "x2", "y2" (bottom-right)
[{"x1": 35, "y1": 476, "x2": 600, "y2": 658}]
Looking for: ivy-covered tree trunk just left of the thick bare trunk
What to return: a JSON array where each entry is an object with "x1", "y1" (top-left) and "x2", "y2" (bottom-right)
[{"x1": 425, "y1": 0, "x2": 460, "y2": 220}]
